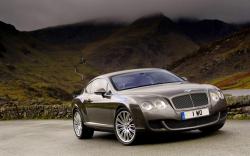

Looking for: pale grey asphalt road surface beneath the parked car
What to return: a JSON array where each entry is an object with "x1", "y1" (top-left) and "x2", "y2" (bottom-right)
[{"x1": 0, "y1": 120, "x2": 250, "y2": 156}]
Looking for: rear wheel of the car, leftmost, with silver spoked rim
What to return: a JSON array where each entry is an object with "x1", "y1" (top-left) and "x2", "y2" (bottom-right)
[{"x1": 73, "y1": 109, "x2": 94, "y2": 139}]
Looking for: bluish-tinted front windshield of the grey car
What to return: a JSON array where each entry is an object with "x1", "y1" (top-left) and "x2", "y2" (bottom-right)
[{"x1": 111, "y1": 70, "x2": 183, "y2": 91}]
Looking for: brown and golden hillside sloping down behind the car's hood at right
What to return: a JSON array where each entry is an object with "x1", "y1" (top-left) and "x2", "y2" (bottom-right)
[{"x1": 171, "y1": 28, "x2": 250, "y2": 89}]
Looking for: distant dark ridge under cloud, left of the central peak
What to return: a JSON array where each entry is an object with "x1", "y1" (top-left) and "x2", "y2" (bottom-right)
[{"x1": 30, "y1": 21, "x2": 125, "y2": 44}]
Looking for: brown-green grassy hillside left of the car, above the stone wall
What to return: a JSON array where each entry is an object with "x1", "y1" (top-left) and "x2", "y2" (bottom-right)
[{"x1": 0, "y1": 35, "x2": 98, "y2": 105}]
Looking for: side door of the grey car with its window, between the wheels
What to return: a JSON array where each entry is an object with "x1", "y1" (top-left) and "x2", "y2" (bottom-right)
[{"x1": 85, "y1": 79, "x2": 113, "y2": 125}]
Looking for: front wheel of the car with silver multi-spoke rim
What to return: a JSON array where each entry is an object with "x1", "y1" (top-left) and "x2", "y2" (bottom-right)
[{"x1": 114, "y1": 108, "x2": 137, "y2": 145}]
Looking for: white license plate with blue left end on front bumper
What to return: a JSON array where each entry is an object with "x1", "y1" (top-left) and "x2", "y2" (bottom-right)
[{"x1": 181, "y1": 108, "x2": 209, "y2": 120}]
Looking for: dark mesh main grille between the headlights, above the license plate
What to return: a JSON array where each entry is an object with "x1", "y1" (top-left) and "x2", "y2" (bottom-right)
[{"x1": 172, "y1": 93, "x2": 208, "y2": 109}]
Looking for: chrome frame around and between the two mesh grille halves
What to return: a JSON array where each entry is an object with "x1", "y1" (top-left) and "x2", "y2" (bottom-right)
[{"x1": 169, "y1": 89, "x2": 211, "y2": 111}]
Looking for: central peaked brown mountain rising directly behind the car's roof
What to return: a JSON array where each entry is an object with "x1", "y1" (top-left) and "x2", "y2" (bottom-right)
[{"x1": 82, "y1": 15, "x2": 199, "y2": 70}]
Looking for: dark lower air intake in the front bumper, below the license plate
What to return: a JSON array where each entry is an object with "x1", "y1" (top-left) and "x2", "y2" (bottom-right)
[{"x1": 164, "y1": 113, "x2": 219, "y2": 129}]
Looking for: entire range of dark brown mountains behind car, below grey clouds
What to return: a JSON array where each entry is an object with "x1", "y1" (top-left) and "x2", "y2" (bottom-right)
[{"x1": 0, "y1": 14, "x2": 250, "y2": 104}]
